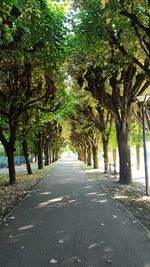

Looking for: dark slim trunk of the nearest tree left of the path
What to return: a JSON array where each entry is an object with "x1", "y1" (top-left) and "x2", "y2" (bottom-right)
[{"x1": 6, "y1": 147, "x2": 16, "y2": 185}]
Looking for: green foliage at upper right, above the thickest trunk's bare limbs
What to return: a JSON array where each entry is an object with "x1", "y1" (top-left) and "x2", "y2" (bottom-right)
[{"x1": 72, "y1": 0, "x2": 149, "y2": 75}]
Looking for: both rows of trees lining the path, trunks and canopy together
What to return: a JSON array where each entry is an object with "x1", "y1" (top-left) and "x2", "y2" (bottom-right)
[{"x1": 0, "y1": 0, "x2": 150, "y2": 184}]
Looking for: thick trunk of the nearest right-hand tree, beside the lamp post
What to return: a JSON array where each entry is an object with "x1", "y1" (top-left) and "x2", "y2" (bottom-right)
[{"x1": 116, "y1": 123, "x2": 132, "y2": 184}]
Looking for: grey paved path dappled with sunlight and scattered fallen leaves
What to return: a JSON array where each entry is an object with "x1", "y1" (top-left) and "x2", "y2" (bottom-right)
[{"x1": 0, "y1": 160, "x2": 150, "y2": 267}]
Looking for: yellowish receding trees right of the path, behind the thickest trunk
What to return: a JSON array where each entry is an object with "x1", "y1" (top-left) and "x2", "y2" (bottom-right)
[{"x1": 70, "y1": 92, "x2": 149, "y2": 177}]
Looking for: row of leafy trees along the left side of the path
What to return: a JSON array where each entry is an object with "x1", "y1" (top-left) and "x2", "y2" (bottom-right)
[{"x1": 0, "y1": 0, "x2": 66, "y2": 184}]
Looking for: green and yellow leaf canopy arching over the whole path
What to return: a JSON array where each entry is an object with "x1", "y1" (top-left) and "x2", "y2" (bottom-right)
[{"x1": 0, "y1": 0, "x2": 149, "y2": 168}]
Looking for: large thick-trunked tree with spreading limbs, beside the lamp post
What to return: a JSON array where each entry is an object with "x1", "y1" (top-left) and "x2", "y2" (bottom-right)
[{"x1": 68, "y1": 1, "x2": 150, "y2": 183}]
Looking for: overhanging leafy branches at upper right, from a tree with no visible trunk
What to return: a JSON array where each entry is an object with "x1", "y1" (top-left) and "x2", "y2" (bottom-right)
[{"x1": 73, "y1": 0, "x2": 150, "y2": 78}]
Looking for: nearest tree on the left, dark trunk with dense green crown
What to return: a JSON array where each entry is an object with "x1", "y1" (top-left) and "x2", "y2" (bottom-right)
[{"x1": 0, "y1": 1, "x2": 67, "y2": 184}]
